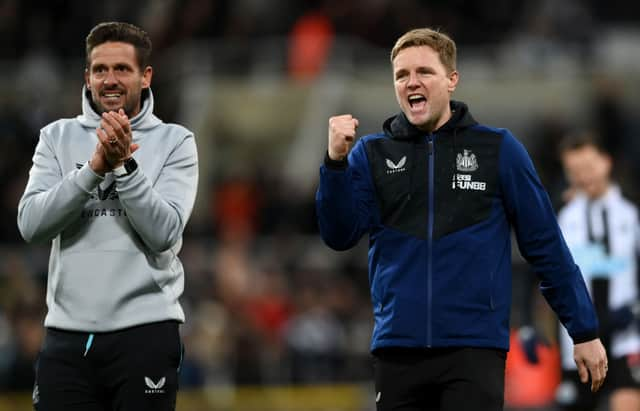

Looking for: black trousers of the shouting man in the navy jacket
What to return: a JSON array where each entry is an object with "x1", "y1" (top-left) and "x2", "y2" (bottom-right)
[{"x1": 374, "y1": 348, "x2": 507, "y2": 411}]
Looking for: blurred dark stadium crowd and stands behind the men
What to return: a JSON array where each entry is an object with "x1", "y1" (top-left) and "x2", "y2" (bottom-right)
[{"x1": 0, "y1": 0, "x2": 640, "y2": 411}]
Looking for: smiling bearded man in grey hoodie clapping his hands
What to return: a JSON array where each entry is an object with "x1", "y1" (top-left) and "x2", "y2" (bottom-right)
[{"x1": 18, "y1": 23, "x2": 198, "y2": 411}]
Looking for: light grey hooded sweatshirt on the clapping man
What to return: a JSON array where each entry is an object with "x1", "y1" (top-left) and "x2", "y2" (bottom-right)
[{"x1": 18, "y1": 89, "x2": 198, "y2": 332}]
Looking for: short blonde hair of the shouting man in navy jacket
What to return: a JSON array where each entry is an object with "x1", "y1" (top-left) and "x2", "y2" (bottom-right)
[{"x1": 391, "y1": 28, "x2": 457, "y2": 72}]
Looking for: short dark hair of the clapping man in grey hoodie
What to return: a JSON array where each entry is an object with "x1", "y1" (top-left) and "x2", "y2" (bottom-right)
[{"x1": 85, "y1": 21, "x2": 151, "y2": 70}]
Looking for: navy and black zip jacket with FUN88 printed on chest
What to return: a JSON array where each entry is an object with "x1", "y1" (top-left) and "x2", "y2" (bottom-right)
[{"x1": 316, "y1": 102, "x2": 598, "y2": 350}]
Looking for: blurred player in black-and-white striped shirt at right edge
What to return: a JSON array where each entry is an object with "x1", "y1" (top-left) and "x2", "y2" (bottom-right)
[{"x1": 556, "y1": 131, "x2": 640, "y2": 411}]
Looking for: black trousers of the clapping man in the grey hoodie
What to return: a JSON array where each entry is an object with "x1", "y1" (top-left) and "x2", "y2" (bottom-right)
[{"x1": 33, "y1": 321, "x2": 183, "y2": 411}]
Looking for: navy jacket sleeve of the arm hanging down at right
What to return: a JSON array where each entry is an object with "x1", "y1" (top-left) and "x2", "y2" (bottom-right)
[{"x1": 500, "y1": 132, "x2": 598, "y2": 344}]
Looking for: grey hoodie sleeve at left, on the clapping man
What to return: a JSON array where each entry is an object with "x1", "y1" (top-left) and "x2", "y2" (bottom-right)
[{"x1": 18, "y1": 131, "x2": 102, "y2": 242}]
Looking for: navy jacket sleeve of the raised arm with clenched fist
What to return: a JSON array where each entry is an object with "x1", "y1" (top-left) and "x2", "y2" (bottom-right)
[{"x1": 316, "y1": 139, "x2": 375, "y2": 251}]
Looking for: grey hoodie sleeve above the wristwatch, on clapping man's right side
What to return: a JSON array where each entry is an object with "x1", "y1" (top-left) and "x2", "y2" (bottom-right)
[{"x1": 116, "y1": 134, "x2": 198, "y2": 253}]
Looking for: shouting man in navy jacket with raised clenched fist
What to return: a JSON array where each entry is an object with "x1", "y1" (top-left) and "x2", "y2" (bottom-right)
[{"x1": 316, "y1": 29, "x2": 607, "y2": 411}]
